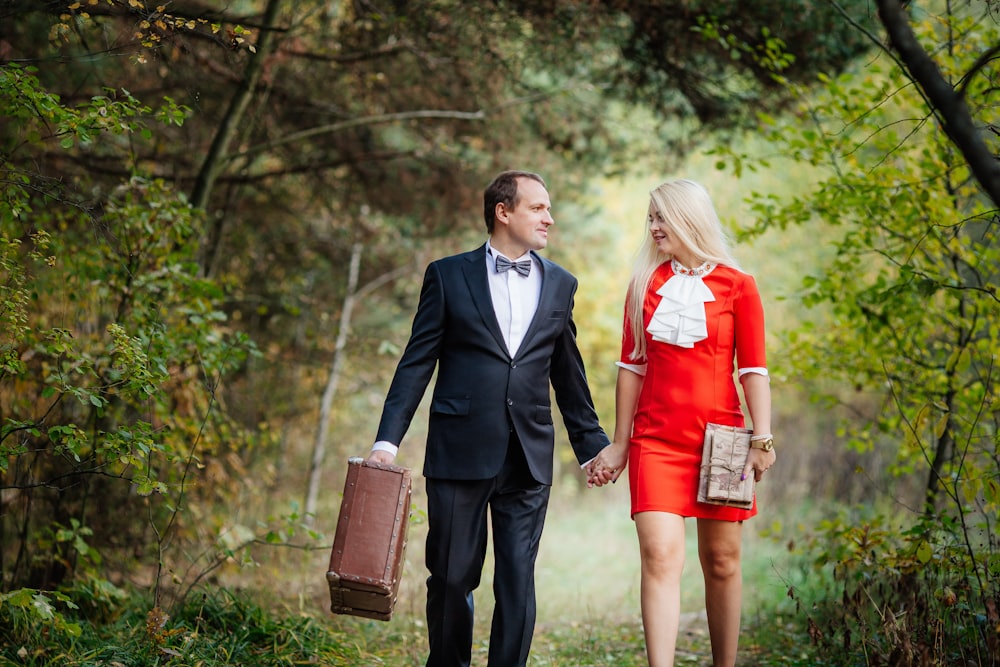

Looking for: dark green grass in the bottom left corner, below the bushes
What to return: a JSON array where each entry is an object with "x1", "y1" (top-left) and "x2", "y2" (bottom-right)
[{"x1": 0, "y1": 589, "x2": 381, "y2": 666}]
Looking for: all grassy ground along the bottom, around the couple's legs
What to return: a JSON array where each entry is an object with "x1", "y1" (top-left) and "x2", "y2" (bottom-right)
[{"x1": 0, "y1": 483, "x2": 822, "y2": 667}]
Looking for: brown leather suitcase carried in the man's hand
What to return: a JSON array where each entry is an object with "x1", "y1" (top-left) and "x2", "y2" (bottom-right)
[{"x1": 326, "y1": 457, "x2": 411, "y2": 621}]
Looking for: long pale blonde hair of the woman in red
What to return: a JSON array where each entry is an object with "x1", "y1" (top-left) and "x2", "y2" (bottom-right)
[{"x1": 625, "y1": 178, "x2": 739, "y2": 362}]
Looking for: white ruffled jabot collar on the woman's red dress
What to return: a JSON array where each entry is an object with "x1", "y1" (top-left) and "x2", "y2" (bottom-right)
[{"x1": 646, "y1": 259, "x2": 716, "y2": 347}]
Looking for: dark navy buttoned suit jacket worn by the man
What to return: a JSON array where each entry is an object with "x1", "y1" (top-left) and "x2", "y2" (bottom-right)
[{"x1": 377, "y1": 245, "x2": 608, "y2": 484}]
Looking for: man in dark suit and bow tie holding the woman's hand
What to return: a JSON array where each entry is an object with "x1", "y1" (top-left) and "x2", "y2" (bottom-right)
[{"x1": 369, "y1": 171, "x2": 608, "y2": 667}]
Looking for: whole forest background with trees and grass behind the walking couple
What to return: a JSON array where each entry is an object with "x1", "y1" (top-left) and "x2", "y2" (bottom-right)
[{"x1": 0, "y1": 0, "x2": 1000, "y2": 666}]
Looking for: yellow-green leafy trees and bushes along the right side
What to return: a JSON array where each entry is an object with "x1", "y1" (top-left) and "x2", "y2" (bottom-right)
[{"x1": 719, "y1": 3, "x2": 1000, "y2": 665}]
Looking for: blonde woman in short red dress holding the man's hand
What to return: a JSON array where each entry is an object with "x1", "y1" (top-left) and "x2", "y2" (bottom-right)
[{"x1": 587, "y1": 180, "x2": 775, "y2": 667}]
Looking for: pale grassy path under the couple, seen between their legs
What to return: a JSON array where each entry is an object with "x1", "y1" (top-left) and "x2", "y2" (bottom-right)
[{"x1": 310, "y1": 486, "x2": 792, "y2": 667}]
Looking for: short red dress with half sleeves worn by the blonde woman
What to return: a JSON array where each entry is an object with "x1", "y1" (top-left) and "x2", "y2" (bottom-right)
[{"x1": 620, "y1": 261, "x2": 767, "y2": 521}]
